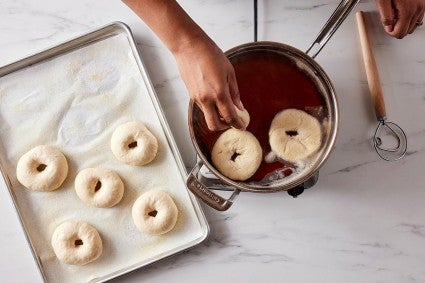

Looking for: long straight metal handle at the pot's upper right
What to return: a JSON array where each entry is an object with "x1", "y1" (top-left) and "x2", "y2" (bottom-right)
[{"x1": 306, "y1": 0, "x2": 360, "y2": 59}]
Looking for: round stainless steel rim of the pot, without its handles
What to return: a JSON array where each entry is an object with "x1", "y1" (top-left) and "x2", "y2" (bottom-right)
[{"x1": 188, "y1": 41, "x2": 339, "y2": 193}]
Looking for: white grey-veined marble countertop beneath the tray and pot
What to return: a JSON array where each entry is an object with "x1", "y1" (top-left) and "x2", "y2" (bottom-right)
[{"x1": 0, "y1": 0, "x2": 425, "y2": 282}]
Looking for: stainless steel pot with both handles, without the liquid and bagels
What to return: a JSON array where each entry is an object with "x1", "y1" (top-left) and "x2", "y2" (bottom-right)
[{"x1": 186, "y1": 0, "x2": 359, "y2": 211}]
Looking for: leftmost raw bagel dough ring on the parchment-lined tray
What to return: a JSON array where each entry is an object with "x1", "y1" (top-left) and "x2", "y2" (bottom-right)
[{"x1": 16, "y1": 145, "x2": 68, "y2": 192}]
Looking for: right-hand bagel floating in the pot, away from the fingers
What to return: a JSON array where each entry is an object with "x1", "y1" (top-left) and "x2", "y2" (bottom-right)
[{"x1": 269, "y1": 109, "x2": 322, "y2": 162}]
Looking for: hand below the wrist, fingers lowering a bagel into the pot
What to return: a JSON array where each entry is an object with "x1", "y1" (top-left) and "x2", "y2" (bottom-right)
[{"x1": 174, "y1": 40, "x2": 244, "y2": 131}]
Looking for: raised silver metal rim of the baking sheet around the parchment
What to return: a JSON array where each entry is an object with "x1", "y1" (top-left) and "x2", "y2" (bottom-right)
[{"x1": 0, "y1": 22, "x2": 210, "y2": 282}]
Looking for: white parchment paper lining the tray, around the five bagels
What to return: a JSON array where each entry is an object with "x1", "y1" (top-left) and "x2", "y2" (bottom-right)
[{"x1": 0, "y1": 34, "x2": 205, "y2": 282}]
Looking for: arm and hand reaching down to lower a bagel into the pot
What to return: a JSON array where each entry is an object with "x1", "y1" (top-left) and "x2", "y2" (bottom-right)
[{"x1": 122, "y1": 0, "x2": 246, "y2": 131}]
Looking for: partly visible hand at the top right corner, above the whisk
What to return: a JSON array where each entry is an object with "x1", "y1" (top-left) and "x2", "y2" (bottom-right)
[{"x1": 376, "y1": 0, "x2": 425, "y2": 38}]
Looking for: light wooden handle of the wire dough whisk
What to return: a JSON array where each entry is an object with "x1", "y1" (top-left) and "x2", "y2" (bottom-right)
[{"x1": 356, "y1": 11, "x2": 387, "y2": 120}]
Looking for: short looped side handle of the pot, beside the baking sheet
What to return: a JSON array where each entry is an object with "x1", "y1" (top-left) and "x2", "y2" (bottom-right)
[{"x1": 186, "y1": 161, "x2": 240, "y2": 211}]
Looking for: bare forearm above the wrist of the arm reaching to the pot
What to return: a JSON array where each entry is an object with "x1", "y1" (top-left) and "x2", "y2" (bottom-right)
[{"x1": 123, "y1": 0, "x2": 212, "y2": 54}]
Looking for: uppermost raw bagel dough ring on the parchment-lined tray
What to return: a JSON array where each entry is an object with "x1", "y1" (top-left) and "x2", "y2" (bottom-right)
[{"x1": 111, "y1": 122, "x2": 158, "y2": 166}]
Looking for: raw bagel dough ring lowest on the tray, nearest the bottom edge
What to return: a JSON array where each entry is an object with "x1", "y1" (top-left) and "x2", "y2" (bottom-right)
[{"x1": 52, "y1": 221, "x2": 102, "y2": 265}]
